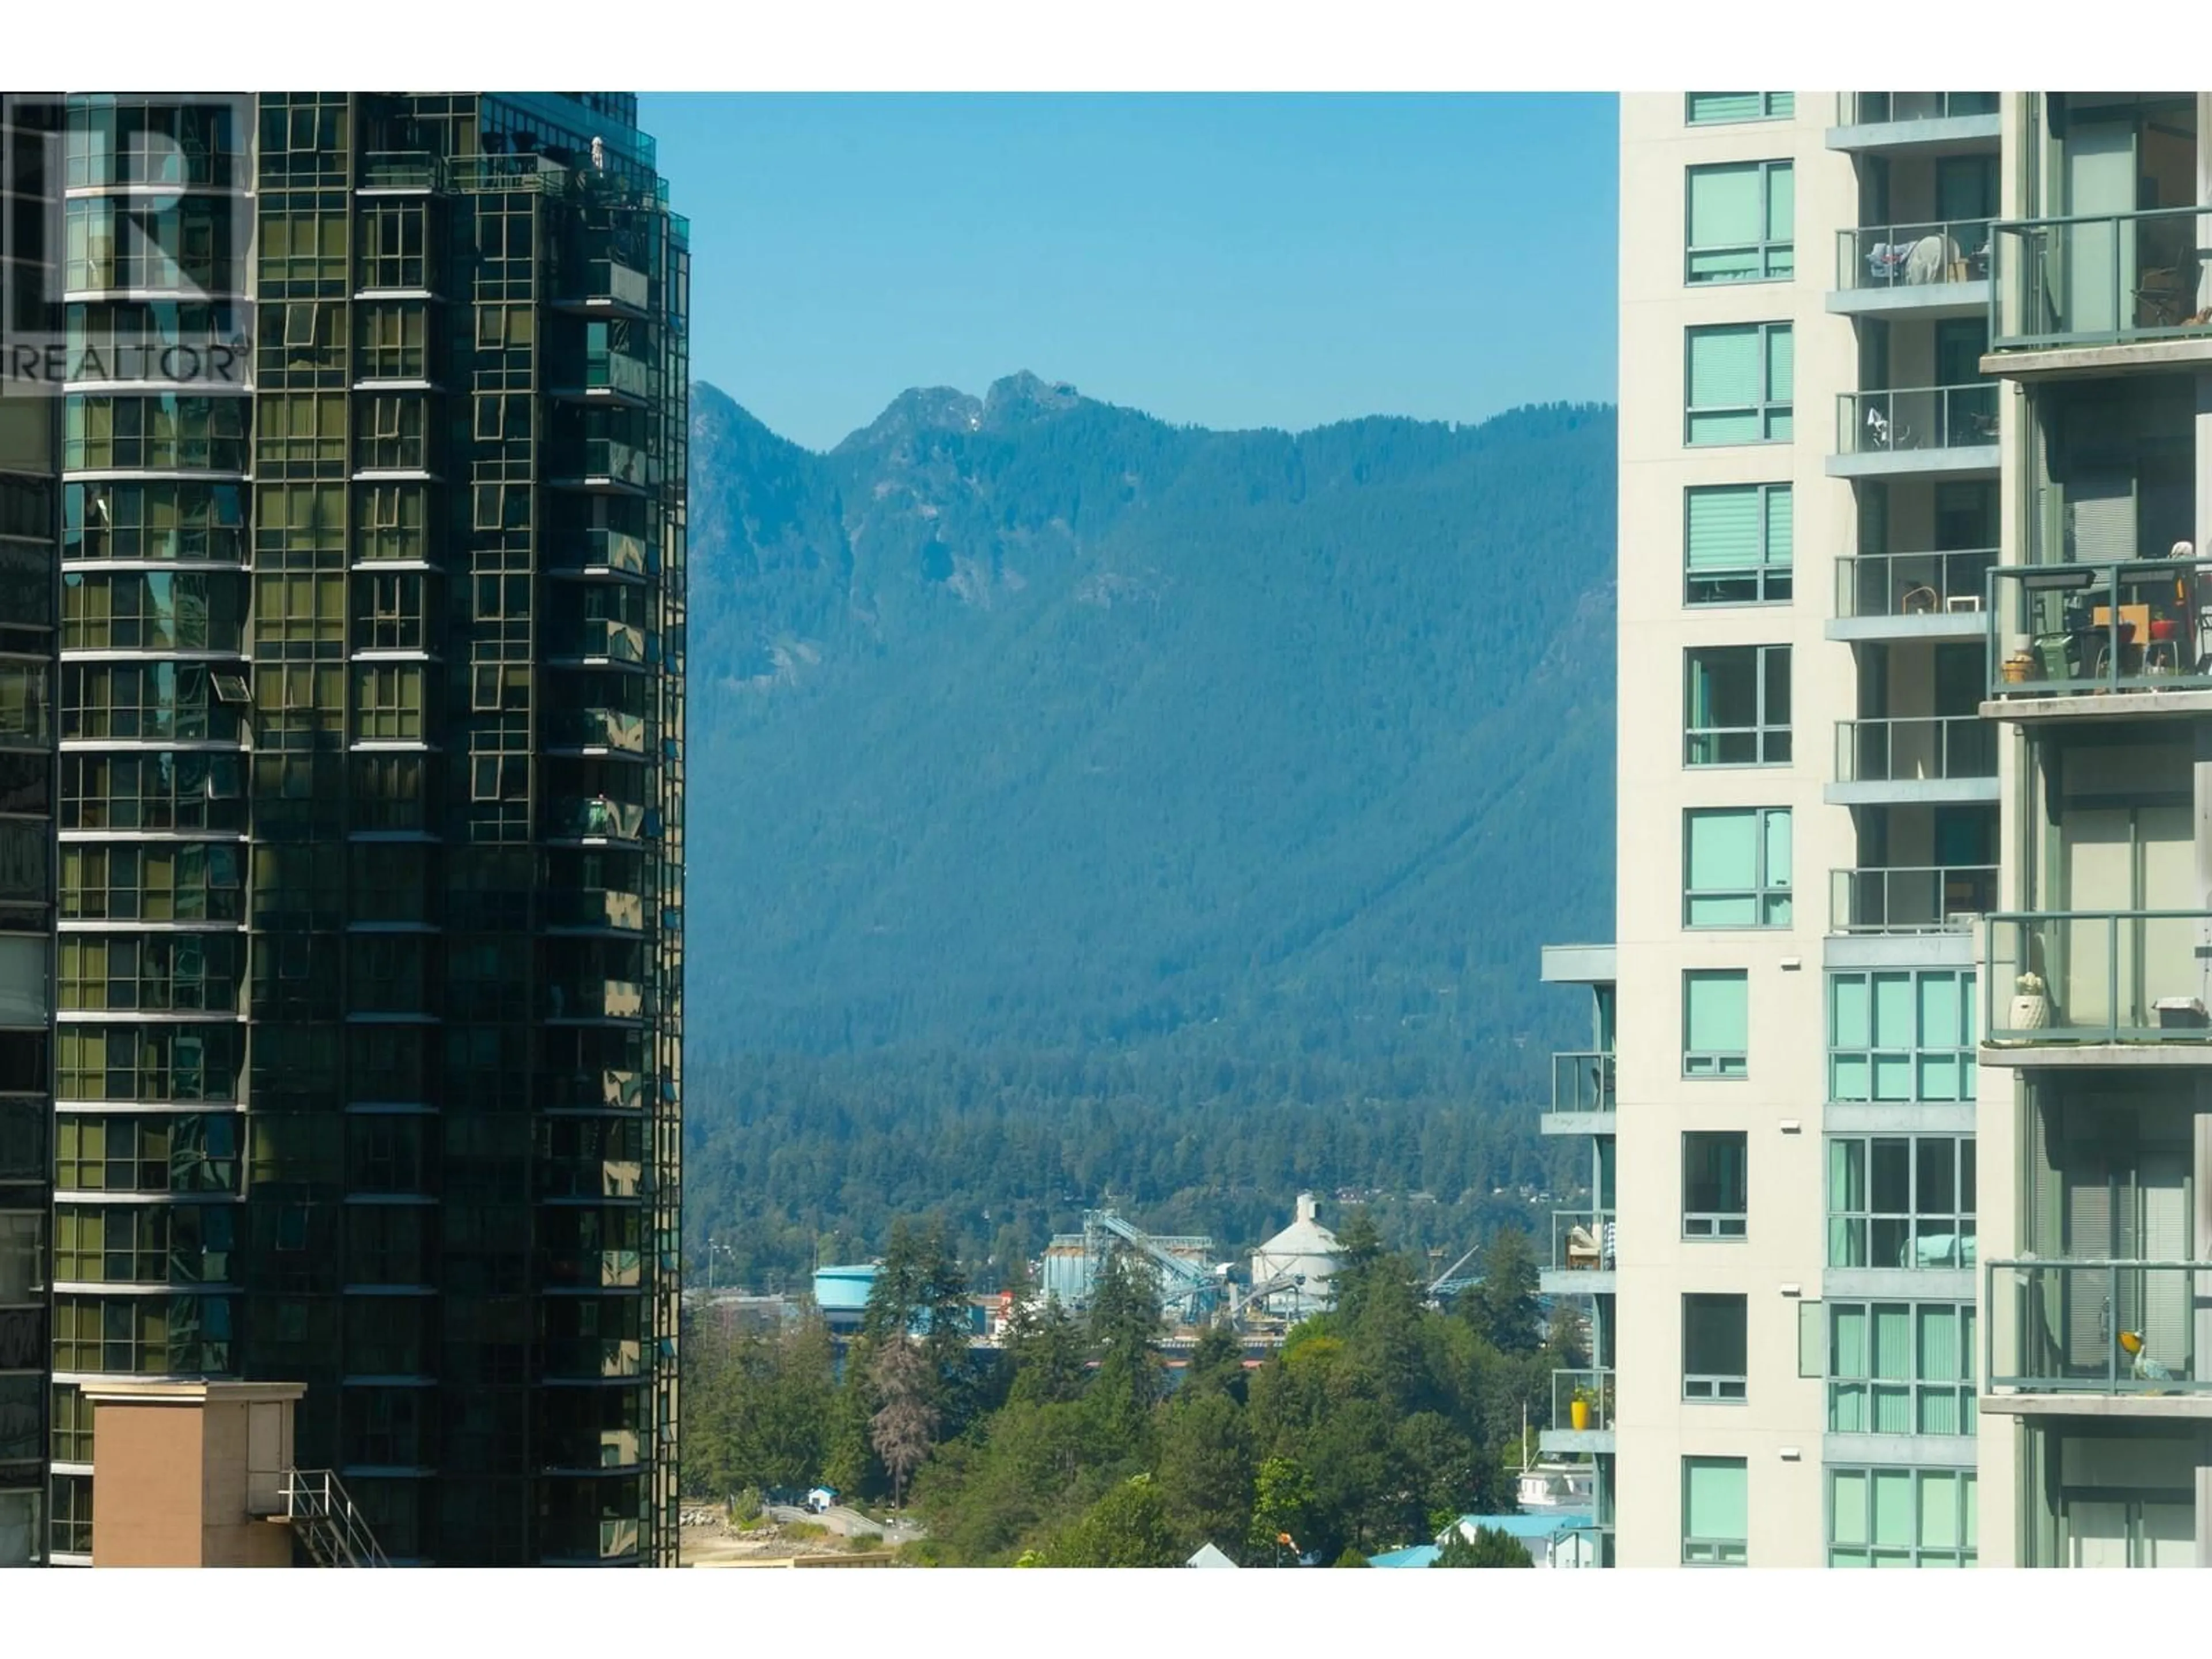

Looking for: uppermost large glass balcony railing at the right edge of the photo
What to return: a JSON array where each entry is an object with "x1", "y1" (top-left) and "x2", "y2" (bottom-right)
[{"x1": 1988, "y1": 208, "x2": 2212, "y2": 352}]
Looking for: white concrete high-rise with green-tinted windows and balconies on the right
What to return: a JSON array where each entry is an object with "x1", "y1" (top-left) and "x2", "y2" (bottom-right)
[{"x1": 1544, "y1": 93, "x2": 2212, "y2": 1566}]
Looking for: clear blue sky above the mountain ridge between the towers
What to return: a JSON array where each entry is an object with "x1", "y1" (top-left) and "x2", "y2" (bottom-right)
[{"x1": 642, "y1": 93, "x2": 1617, "y2": 449}]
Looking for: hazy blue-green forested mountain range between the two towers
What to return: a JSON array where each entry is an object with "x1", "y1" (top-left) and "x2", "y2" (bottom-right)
[{"x1": 685, "y1": 374, "x2": 1612, "y2": 1283}]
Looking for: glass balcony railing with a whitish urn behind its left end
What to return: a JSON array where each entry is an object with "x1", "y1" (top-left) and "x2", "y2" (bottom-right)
[{"x1": 1984, "y1": 909, "x2": 2212, "y2": 1042}]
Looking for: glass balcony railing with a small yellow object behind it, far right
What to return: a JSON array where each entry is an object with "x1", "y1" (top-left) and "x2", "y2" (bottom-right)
[{"x1": 1982, "y1": 1261, "x2": 2212, "y2": 1393}]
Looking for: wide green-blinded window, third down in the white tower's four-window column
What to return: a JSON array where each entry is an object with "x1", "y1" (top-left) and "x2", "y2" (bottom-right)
[{"x1": 1825, "y1": 1303, "x2": 1975, "y2": 1435}]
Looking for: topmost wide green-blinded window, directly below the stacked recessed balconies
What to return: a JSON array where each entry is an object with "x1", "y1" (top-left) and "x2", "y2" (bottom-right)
[{"x1": 1827, "y1": 969, "x2": 1980, "y2": 1101}]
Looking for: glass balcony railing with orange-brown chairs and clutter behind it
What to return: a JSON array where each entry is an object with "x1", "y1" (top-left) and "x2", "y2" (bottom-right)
[{"x1": 1988, "y1": 558, "x2": 2212, "y2": 697}]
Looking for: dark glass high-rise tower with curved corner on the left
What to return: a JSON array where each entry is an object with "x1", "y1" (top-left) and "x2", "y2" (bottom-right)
[{"x1": 0, "y1": 93, "x2": 690, "y2": 1566}]
